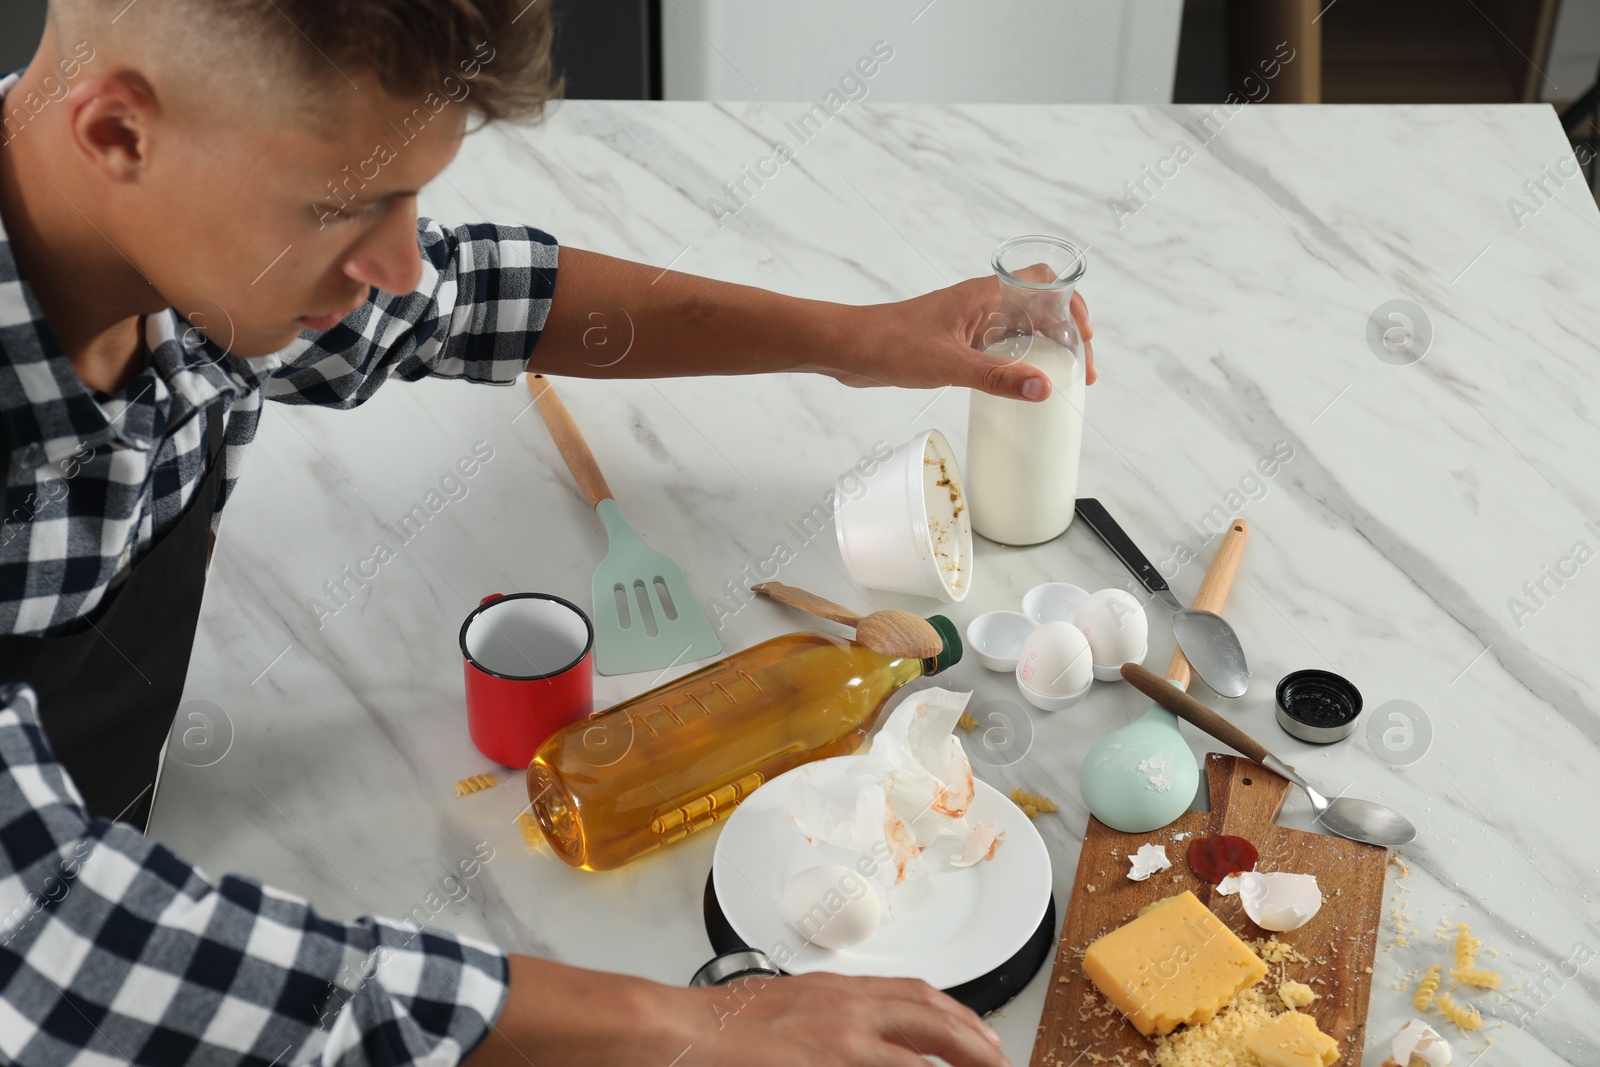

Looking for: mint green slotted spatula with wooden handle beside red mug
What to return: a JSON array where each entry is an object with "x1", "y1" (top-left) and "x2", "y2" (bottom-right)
[{"x1": 528, "y1": 374, "x2": 722, "y2": 675}]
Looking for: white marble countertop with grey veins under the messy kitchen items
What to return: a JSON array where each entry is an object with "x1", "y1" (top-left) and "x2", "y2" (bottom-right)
[{"x1": 154, "y1": 102, "x2": 1600, "y2": 1065}]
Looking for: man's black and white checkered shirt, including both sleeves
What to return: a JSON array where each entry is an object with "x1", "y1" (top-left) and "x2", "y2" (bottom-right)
[{"x1": 0, "y1": 66, "x2": 558, "y2": 1067}]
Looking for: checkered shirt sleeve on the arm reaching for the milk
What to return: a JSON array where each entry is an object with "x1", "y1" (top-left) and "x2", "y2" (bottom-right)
[{"x1": 266, "y1": 218, "x2": 560, "y2": 408}]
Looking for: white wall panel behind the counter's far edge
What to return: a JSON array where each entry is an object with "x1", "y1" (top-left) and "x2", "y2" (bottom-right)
[{"x1": 661, "y1": 0, "x2": 1182, "y2": 104}]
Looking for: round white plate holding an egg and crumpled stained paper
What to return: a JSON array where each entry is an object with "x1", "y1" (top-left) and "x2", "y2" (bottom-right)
[{"x1": 710, "y1": 755, "x2": 1051, "y2": 989}]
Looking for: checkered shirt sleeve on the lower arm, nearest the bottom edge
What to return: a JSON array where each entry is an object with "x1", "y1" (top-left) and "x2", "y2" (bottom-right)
[{"x1": 0, "y1": 685, "x2": 509, "y2": 1067}]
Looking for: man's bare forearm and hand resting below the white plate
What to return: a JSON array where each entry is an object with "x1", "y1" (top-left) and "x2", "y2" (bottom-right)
[{"x1": 467, "y1": 955, "x2": 1008, "y2": 1067}]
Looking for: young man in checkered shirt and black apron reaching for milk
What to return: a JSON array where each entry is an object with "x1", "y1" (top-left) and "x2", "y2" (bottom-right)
[{"x1": 0, "y1": 0, "x2": 1093, "y2": 1067}]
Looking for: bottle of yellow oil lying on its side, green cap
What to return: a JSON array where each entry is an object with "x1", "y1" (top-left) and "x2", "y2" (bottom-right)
[{"x1": 528, "y1": 616, "x2": 962, "y2": 870}]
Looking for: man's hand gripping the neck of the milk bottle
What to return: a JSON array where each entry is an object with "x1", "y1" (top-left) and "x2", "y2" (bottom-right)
[{"x1": 811, "y1": 277, "x2": 1096, "y2": 400}]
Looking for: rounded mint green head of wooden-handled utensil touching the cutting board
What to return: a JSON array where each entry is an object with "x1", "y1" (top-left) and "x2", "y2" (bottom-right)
[{"x1": 1078, "y1": 707, "x2": 1200, "y2": 833}]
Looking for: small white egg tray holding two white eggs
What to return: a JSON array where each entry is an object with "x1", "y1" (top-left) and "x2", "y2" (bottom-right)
[{"x1": 966, "y1": 582, "x2": 1150, "y2": 712}]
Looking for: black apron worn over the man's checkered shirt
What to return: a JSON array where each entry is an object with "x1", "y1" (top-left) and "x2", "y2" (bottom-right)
[{"x1": 0, "y1": 400, "x2": 222, "y2": 830}]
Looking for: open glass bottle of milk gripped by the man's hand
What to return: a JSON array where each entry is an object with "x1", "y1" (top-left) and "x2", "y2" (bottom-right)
[{"x1": 965, "y1": 237, "x2": 1088, "y2": 545}]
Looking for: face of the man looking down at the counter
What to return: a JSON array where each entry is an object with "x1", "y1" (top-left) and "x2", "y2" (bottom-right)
[{"x1": 110, "y1": 80, "x2": 467, "y2": 357}]
